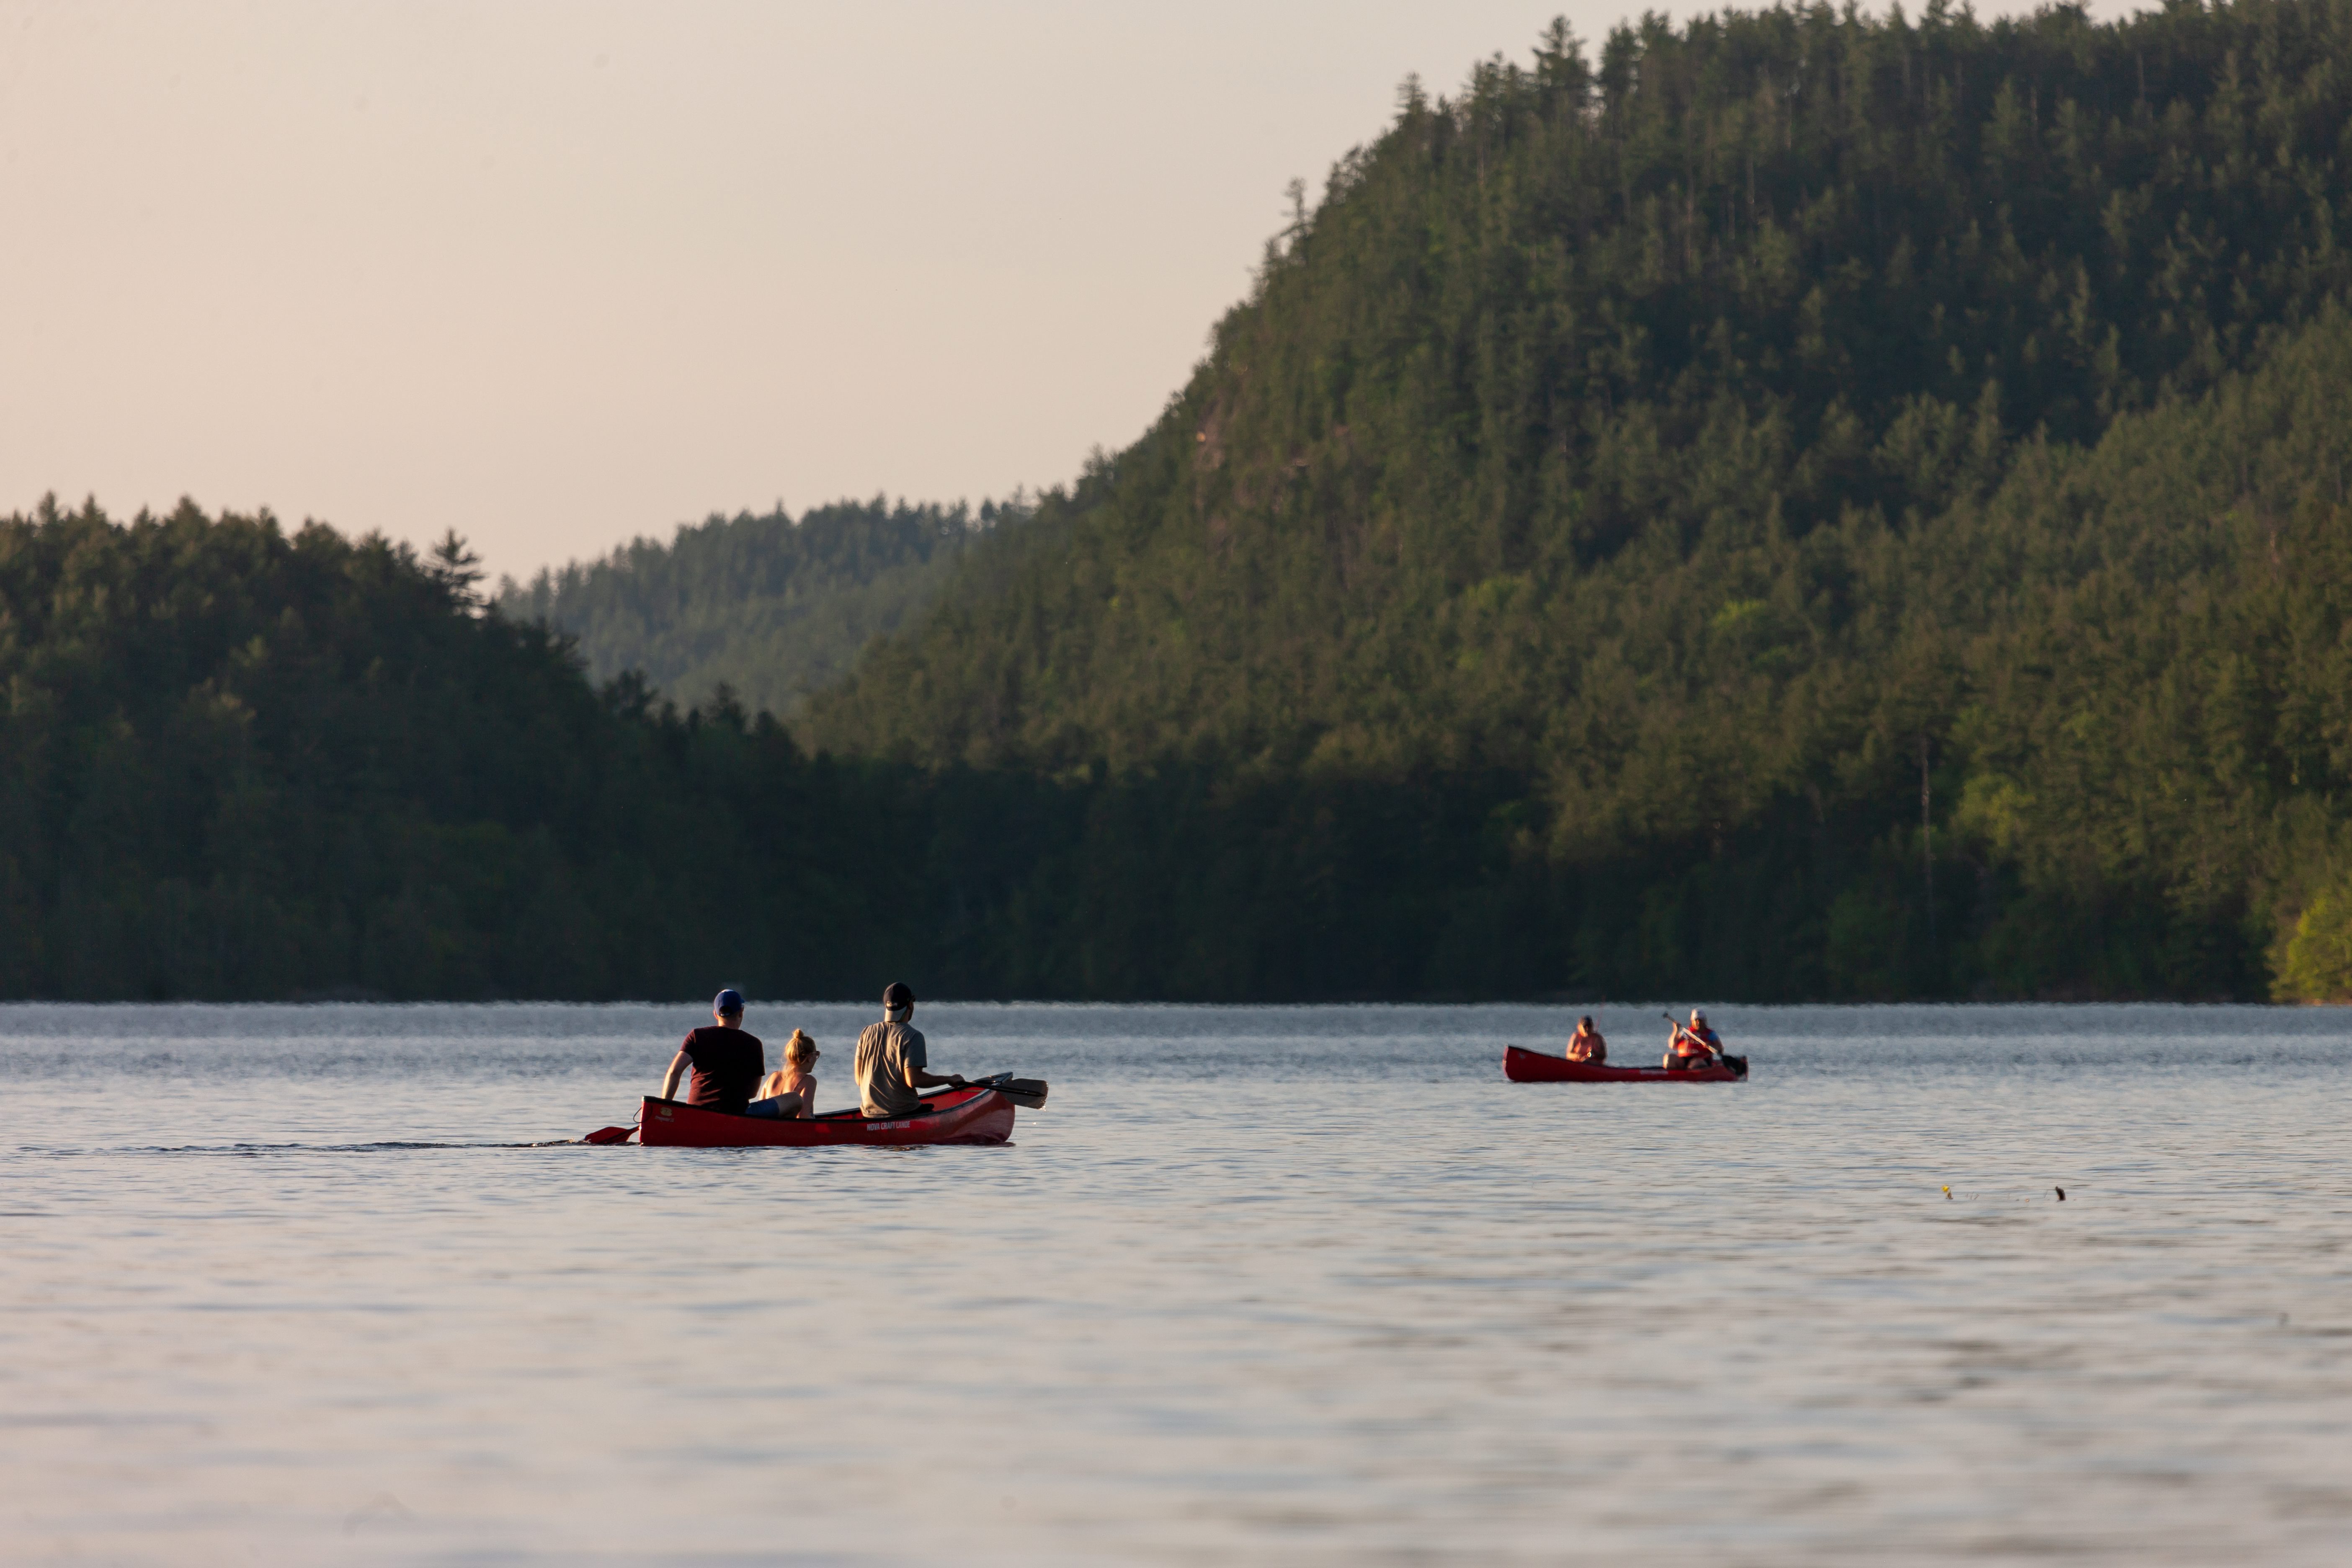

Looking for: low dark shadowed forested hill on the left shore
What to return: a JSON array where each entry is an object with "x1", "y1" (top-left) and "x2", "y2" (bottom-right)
[{"x1": 0, "y1": 503, "x2": 959, "y2": 999}]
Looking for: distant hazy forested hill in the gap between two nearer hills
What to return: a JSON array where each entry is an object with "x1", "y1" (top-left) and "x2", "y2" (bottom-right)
[{"x1": 499, "y1": 496, "x2": 997, "y2": 712}]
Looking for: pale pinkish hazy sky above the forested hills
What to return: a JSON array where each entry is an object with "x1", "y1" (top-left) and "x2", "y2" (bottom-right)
[{"x1": 0, "y1": 0, "x2": 2124, "y2": 574}]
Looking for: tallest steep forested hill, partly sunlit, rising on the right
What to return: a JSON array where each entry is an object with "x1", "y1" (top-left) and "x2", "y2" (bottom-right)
[{"x1": 805, "y1": 0, "x2": 2352, "y2": 994}]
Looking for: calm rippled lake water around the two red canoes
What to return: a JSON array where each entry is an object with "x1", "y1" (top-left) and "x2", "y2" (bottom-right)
[{"x1": 0, "y1": 1004, "x2": 2352, "y2": 1563}]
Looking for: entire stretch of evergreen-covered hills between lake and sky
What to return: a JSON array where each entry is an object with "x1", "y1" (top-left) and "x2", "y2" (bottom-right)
[{"x1": 13, "y1": 0, "x2": 2352, "y2": 1001}]
